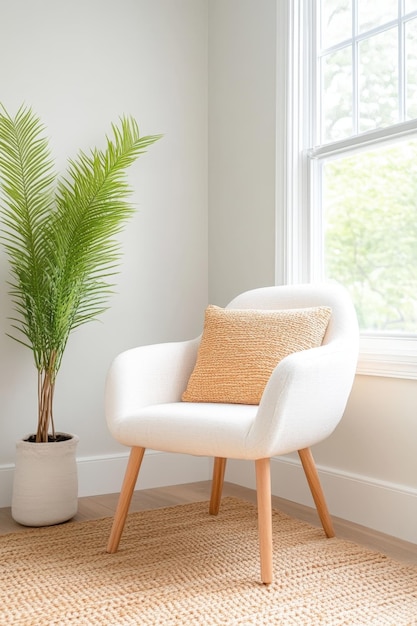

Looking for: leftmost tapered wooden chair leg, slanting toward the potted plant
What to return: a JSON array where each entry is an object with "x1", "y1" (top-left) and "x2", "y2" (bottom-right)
[{"x1": 107, "y1": 447, "x2": 145, "y2": 554}]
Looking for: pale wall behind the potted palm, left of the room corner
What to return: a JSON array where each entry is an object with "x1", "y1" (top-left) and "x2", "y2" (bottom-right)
[{"x1": 0, "y1": 0, "x2": 208, "y2": 488}]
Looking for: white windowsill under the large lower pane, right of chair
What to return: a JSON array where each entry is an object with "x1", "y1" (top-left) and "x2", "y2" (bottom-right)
[{"x1": 356, "y1": 336, "x2": 417, "y2": 380}]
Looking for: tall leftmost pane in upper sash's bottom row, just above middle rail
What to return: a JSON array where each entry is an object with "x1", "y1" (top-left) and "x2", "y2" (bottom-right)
[{"x1": 321, "y1": 46, "x2": 353, "y2": 143}]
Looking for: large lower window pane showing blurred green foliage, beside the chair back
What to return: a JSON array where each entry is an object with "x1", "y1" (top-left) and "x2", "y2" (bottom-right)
[{"x1": 323, "y1": 140, "x2": 417, "y2": 334}]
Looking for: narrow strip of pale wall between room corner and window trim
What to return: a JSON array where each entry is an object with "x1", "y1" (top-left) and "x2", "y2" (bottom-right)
[{"x1": 209, "y1": 0, "x2": 276, "y2": 306}]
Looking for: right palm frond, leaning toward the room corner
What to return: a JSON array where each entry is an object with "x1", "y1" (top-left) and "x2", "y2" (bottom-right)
[{"x1": 45, "y1": 117, "x2": 159, "y2": 370}]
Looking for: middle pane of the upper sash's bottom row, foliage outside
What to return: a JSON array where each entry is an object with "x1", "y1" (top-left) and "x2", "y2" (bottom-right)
[{"x1": 358, "y1": 28, "x2": 399, "y2": 132}]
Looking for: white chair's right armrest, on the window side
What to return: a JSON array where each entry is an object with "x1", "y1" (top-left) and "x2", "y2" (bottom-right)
[{"x1": 247, "y1": 341, "x2": 357, "y2": 457}]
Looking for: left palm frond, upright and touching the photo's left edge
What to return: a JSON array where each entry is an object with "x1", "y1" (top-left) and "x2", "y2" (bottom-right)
[{"x1": 0, "y1": 107, "x2": 55, "y2": 368}]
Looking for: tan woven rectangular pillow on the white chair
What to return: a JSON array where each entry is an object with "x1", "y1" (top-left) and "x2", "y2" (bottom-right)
[{"x1": 182, "y1": 305, "x2": 331, "y2": 404}]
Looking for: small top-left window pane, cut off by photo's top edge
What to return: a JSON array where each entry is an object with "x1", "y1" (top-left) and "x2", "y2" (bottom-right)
[{"x1": 321, "y1": 0, "x2": 352, "y2": 49}]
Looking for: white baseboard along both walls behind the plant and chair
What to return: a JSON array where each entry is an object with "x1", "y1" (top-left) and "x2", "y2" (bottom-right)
[{"x1": 0, "y1": 450, "x2": 417, "y2": 543}]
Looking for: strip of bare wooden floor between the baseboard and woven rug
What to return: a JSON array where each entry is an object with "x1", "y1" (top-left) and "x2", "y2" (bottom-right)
[{"x1": 0, "y1": 481, "x2": 417, "y2": 565}]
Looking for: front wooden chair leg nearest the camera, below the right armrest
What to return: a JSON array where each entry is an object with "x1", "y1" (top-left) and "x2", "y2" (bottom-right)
[{"x1": 255, "y1": 459, "x2": 273, "y2": 585}]
